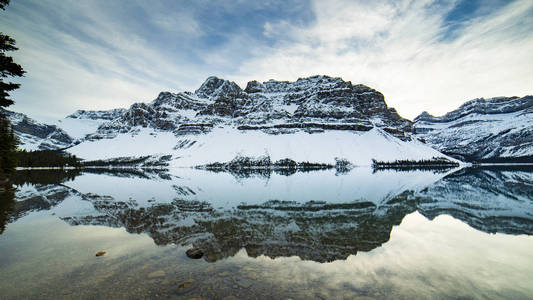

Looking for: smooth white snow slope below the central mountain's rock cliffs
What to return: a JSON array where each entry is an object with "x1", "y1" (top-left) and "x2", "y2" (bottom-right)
[{"x1": 68, "y1": 127, "x2": 443, "y2": 167}]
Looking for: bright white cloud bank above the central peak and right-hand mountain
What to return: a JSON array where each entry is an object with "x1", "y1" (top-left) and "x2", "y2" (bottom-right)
[{"x1": 234, "y1": 0, "x2": 533, "y2": 118}]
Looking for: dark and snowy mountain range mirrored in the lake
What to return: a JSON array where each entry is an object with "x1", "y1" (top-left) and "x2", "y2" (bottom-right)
[{"x1": 0, "y1": 167, "x2": 533, "y2": 262}]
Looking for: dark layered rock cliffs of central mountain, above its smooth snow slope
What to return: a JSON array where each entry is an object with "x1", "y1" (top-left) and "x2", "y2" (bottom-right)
[{"x1": 90, "y1": 76, "x2": 412, "y2": 139}]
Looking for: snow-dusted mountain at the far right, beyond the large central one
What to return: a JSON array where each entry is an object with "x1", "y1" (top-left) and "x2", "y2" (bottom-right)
[{"x1": 414, "y1": 96, "x2": 533, "y2": 162}]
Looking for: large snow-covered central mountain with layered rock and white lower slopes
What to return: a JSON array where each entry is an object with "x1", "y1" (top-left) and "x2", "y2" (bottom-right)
[{"x1": 61, "y1": 76, "x2": 443, "y2": 167}]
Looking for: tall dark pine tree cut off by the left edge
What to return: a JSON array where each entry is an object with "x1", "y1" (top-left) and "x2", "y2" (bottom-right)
[{"x1": 0, "y1": 0, "x2": 25, "y2": 177}]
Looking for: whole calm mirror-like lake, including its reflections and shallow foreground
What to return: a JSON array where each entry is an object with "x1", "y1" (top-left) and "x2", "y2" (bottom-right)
[{"x1": 0, "y1": 167, "x2": 533, "y2": 300}]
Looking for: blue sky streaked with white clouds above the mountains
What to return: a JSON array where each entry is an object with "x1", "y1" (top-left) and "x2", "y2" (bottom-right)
[{"x1": 0, "y1": 0, "x2": 533, "y2": 120}]
